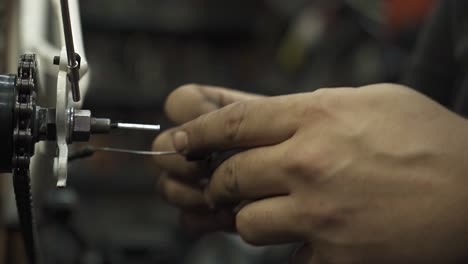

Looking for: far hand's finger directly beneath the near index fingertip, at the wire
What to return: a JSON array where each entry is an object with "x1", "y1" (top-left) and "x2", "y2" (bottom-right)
[{"x1": 153, "y1": 129, "x2": 208, "y2": 182}]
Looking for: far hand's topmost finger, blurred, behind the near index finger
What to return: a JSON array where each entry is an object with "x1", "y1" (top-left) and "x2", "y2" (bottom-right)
[{"x1": 165, "y1": 84, "x2": 261, "y2": 124}]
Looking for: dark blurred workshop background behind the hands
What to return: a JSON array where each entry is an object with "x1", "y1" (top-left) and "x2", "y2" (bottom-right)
[{"x1": 0, "y1": 0, "x2": 435, "y2": 264}]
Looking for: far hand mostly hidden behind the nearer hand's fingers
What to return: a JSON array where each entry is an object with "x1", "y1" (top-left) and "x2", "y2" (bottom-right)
[{"x1": 153, "y1": 84, "x2": 261, "y2": 232}]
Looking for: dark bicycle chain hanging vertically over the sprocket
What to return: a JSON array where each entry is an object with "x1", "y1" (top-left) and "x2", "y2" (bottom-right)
[{"x1": 13, "y1": 54, "x2": 38, "y2": 264}]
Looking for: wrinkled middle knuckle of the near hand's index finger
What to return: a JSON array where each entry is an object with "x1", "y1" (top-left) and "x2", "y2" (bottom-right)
[{"x1": 223, "y1": 102, "x2": 247, "y2": 142}]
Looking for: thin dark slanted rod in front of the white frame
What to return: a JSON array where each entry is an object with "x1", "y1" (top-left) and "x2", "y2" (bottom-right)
[{"x1": 60, "y1": 0, "x2": 81, "y2": 102}]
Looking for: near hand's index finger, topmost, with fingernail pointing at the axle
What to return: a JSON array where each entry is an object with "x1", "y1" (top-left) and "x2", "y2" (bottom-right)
[{"x1": 173, "y1": 96, "x2": 300, "y2": 156}]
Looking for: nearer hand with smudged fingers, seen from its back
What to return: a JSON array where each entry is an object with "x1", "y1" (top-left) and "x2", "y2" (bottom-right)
[{"x1": 166, "y1": 84, "x2": 468, "y2": 264}]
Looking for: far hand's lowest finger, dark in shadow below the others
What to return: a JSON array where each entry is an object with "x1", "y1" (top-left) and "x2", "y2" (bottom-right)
[{"x1": 180, "y1": 209, "x2": 235, "y2": 233}]
